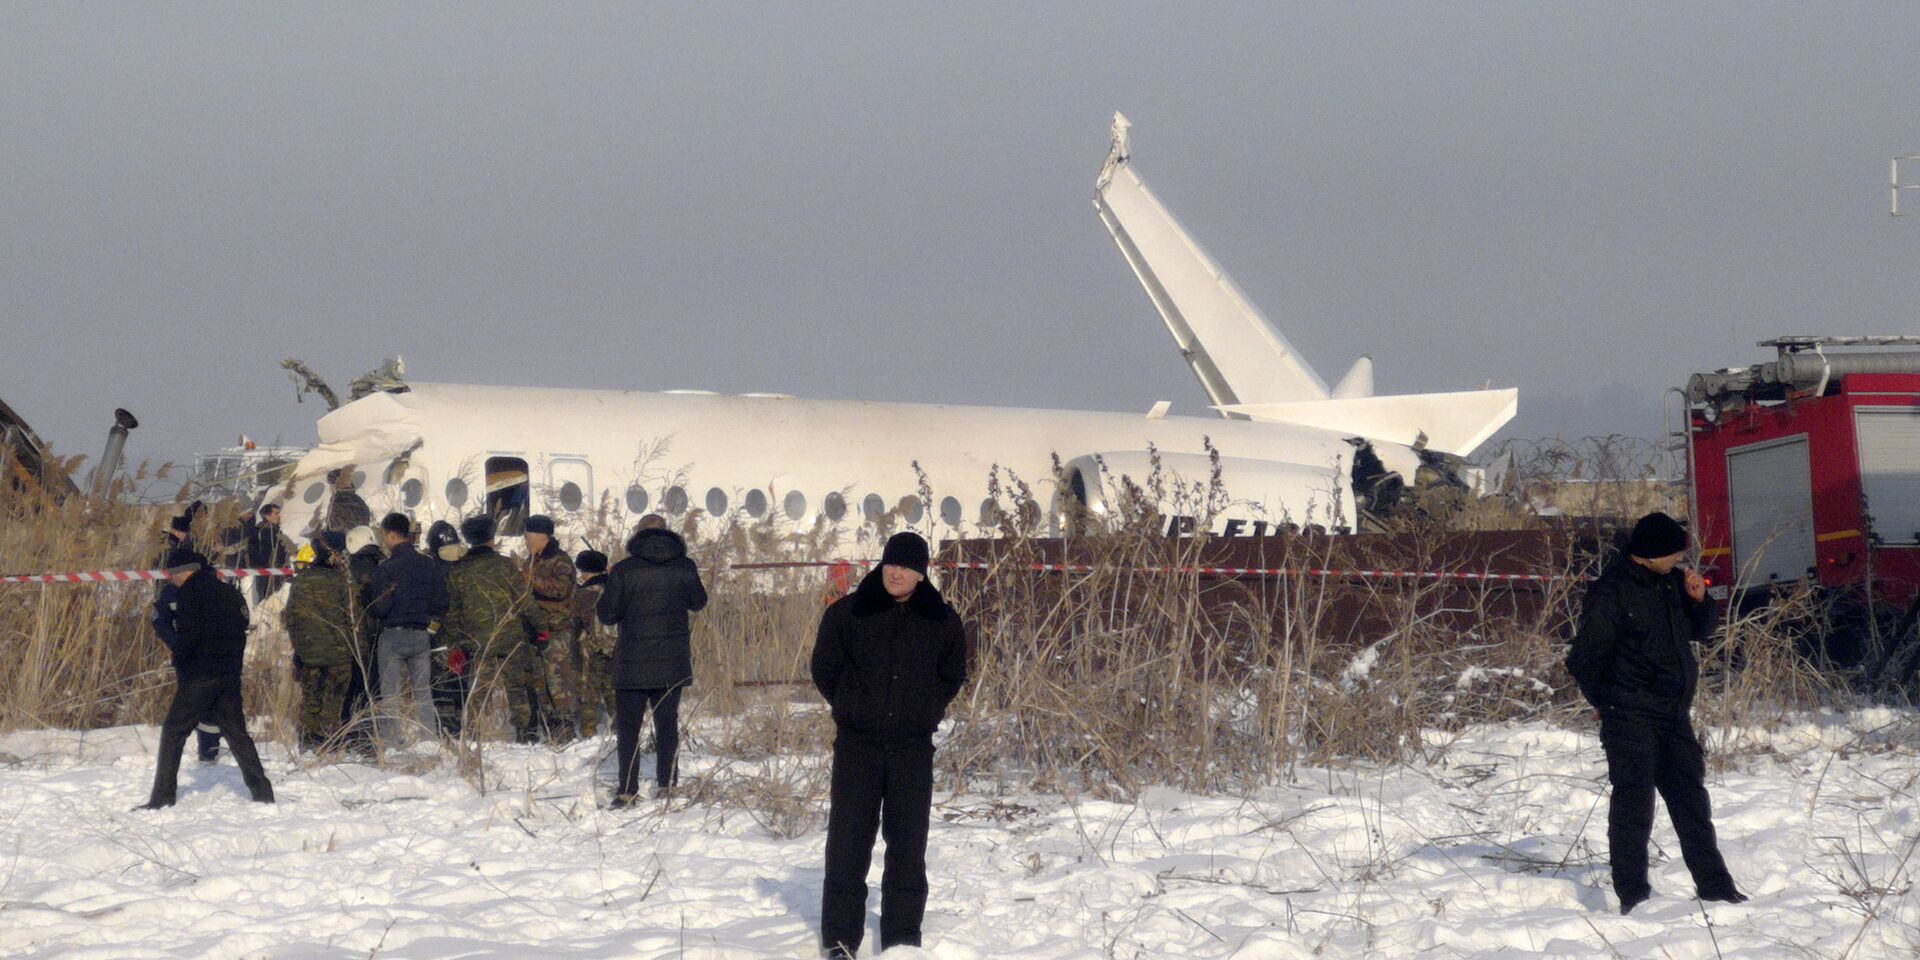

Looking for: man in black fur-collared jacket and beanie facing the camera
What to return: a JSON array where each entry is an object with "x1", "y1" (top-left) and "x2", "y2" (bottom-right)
[{"x1": 812, "y1": 534, "x2": 966, "y2": 958}]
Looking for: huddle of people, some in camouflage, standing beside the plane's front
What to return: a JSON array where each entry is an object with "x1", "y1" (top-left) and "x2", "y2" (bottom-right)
[{"x1": 284, "y1": 513, "x2": 707, "y2": 806}]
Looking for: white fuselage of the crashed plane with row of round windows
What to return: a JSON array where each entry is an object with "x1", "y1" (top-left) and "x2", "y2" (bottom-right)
[{"x1": 286, "y1": 384, "x2": 1374, "y2": 549}]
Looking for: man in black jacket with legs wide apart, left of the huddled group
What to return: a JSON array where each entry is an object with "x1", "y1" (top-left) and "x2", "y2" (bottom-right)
[{"x1": 142, "y1": 549, "x2": 273, "y2": 810}]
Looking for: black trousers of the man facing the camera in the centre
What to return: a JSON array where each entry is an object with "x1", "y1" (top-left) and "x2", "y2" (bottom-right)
[{"x1": 820, "y1": 732, "x2": 933, "y2": 954}]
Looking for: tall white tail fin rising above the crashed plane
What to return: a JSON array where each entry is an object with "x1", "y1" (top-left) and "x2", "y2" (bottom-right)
[{"x1": 1092, "y1": 113, "x2": 1328, "y2": 417}]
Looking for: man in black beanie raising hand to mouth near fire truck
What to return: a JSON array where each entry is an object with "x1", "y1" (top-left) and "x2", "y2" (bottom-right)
[{"x1": 1567, "y1": 513, "x2": 1747, "y2": 914}]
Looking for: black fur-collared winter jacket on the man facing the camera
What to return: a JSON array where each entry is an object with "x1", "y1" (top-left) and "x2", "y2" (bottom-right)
[{"x1": 812, "y1": 568, "x2": 966, "y2": 743}]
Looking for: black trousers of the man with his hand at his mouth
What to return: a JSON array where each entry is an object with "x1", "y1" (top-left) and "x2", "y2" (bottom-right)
[{"x1": 1599, "y1": 716, "x2": 1734, "y2": 900}]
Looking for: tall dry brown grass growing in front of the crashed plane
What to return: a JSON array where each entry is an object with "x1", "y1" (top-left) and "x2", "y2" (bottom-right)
[{"x1": 0, "y1": 439, "x2": 1873, "y2": 802}]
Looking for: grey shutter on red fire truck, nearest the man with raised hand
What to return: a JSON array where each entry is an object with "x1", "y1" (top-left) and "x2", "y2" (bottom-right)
[{"x1": 1726, "y1": 434, "x2": 1814, "y2": 586}]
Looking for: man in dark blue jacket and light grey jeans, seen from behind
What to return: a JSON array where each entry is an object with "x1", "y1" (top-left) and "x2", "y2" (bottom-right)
[{"x1": 367, "y1": 513, "x2": 447, "y2": 743}]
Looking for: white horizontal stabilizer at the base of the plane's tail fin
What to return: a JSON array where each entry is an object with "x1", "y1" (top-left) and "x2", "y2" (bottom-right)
[{"x1": 1219, "y1": 388, "x2": 1521, "y2": 457}]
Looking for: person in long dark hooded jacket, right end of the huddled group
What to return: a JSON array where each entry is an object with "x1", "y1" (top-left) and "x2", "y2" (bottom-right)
[{"x1": 593, "y1": 515, "x2": 707, "y2": 806}]
